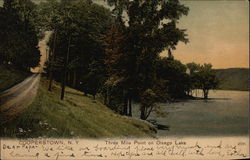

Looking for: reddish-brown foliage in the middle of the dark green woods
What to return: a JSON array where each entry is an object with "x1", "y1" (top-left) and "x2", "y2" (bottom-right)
[{"x1": 104, "y1": 24, "x2": 133, "y2": 111}]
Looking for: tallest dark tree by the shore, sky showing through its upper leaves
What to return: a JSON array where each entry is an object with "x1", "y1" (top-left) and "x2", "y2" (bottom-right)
[{"x1": 107, "y1": 0, "x2": 188, "y2": 119}]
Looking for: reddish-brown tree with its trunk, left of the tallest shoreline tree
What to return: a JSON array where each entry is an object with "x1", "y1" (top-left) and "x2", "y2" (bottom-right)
[{"x1": 105, "y1": 23, "x2": 132, "y2": 116}]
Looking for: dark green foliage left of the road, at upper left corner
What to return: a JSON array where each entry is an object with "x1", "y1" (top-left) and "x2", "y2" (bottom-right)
[{"x1": 0, "y1": 0, "x2": 40, "y2": 71}]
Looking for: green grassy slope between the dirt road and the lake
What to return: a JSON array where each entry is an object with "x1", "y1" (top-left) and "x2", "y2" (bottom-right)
[{"x1": 1, "y1": 78, "x2": 155, "y2": 138}]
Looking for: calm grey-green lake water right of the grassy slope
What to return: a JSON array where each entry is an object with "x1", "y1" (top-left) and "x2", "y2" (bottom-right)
[{"x1": 134, "y1": 90, "x2": 249, "y2": 136}]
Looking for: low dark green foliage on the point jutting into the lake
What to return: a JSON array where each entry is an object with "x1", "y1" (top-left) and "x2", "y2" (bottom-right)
[{"x1": 155, "y1": 58, "x2": 219, "y2": 101}]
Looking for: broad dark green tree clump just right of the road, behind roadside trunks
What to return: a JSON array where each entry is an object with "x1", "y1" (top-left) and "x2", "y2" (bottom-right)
[{"x1": 41, "y1": 0, "x2": 111, "y2": 99}]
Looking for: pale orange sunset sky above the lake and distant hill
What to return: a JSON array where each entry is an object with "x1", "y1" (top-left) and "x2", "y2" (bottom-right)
[{"x1": 161, "y1": 0, "x2": 249, "y2": 68}]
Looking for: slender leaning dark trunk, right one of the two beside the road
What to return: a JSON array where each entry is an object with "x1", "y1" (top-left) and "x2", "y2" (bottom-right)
[{"x1": 61, "y1": 36, "x2": 71, "y2": 100}]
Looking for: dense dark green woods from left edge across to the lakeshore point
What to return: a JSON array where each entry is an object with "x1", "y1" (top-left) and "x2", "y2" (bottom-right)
[{"x1": 0, "y1": 0, "x2": 219, "y2": 120}]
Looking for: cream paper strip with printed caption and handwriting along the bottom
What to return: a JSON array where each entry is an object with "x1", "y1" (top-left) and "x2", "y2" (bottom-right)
[{"x1": 0, "y1": 0, "x2": 250, "y2": 160}]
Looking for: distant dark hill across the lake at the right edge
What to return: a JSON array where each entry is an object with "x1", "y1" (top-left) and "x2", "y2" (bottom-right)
[{"x1": 215, "y1": 68, "x2": 249, "y2": 91}]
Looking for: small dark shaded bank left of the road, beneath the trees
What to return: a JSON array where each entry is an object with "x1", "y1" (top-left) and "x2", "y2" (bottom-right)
[{"x1": 0, "y1": 65, "x2": 29, "y2": 92}]
